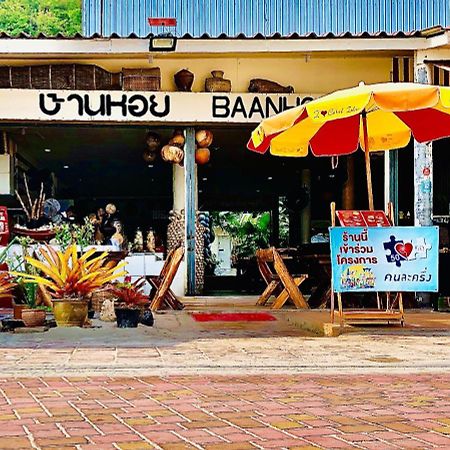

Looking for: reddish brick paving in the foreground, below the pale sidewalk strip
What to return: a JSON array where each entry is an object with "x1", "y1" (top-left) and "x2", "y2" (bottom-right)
[{"x1": 0, "y1": 375, "x2": 450, "y2": 450}]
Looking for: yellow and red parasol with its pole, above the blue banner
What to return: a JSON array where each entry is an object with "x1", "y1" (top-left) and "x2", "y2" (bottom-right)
[{"x1": 247, "y1": 83, "x2": 450, "y2": 209}]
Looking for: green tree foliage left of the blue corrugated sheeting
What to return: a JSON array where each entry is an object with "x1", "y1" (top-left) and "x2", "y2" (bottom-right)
[{"x1": 0, "y1": 0, "x2": 81, "y2": 36}]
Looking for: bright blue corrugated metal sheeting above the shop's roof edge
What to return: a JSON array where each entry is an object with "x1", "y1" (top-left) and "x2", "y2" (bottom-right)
[{"x1": 83, "y1": 0, "x2": 450, "y2": 37}]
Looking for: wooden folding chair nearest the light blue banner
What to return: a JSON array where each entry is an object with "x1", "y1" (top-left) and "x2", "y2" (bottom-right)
[{"x1": 256, "y1": 247, "x2": 309, "y2": 309}]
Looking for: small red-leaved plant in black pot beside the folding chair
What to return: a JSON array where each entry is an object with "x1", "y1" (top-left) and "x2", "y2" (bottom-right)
[{"x1": 109, "y1": 278, "x2": 149, "y2": 328}]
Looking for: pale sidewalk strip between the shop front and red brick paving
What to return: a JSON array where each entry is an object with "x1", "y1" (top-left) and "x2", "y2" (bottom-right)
[{"x1": 0, "y1": 311, "x2": 450, "y2": 376}]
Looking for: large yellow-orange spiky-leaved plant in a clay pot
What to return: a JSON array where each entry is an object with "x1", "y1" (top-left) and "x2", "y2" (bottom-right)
[{"x1": 12, "y1": 244, "x2": 126, "y2": 327}]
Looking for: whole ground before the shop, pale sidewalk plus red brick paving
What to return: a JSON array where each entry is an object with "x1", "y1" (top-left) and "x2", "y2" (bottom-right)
[{"x1": 0, "y1": 314, "x2": 450, "y2": 450}]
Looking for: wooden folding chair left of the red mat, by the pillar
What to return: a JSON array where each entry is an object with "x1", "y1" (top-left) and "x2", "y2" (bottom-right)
[{"x1": 146, "y1": 247, "x2": 184, "y2": 311}]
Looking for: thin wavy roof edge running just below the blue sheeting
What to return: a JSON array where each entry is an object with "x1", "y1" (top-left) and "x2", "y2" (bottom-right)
[{"x1": 0, "y1": 28, "x2": 428, "y2": 40}]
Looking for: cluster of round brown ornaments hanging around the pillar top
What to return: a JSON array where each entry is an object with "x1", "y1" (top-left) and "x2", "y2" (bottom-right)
[{"x1": 142, "y1": 130, "x2": 213, "y2": 165}]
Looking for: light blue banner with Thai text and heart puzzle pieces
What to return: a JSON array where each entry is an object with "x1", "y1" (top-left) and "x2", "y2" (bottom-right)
[{"x1": 330, "y1": 227, "x2": 439, "y2": 292}]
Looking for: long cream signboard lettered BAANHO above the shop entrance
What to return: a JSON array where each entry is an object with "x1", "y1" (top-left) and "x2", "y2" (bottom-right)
[{"x1": 0, "y1": 89, "x2": 313, "y2": 124}]
